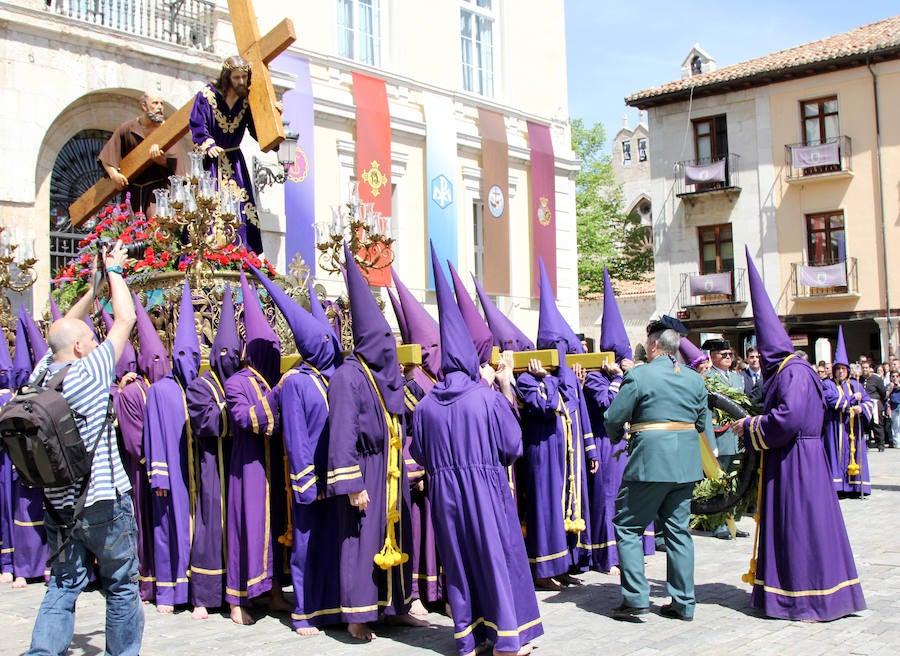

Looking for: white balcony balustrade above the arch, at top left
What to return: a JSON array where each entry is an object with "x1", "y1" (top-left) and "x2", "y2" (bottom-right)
[{"x1": 52, "y1": 0, "x2": 216, "y2": 51}]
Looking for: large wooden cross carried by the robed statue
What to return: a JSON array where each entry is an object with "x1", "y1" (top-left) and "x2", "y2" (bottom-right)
[{"x1": 69, "y1": 0, "x2": 297, "y2": 227}]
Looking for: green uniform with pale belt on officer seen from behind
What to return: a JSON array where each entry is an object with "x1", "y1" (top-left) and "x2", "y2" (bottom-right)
[{"x1": 604, "y1": 353, "x2": 713, "y2": 617}]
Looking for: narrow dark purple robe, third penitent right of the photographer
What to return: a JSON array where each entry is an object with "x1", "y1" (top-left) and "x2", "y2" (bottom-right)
[{"x1": 185, "y1": 370, "x2": 231, "y2": 608}]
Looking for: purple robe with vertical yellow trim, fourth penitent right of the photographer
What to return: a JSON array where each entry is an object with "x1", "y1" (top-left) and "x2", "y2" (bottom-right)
[{"x1": 224, "y1": 367, "x2": 288, "y2": 606}]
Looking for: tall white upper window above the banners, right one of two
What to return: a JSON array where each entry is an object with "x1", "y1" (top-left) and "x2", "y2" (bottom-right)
[{"x1": 459, "y1": 0, "x2": 500, "y2": 98}]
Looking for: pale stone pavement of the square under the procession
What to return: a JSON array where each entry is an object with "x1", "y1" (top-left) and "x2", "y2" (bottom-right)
[{"x1": 0, "y1": 449, "x2": 900, "y2": 656}]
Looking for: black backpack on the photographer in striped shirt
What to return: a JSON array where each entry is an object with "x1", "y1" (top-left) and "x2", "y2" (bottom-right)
[{"x1": 0, "y1": 365, "x2": 112, "y2": 564}]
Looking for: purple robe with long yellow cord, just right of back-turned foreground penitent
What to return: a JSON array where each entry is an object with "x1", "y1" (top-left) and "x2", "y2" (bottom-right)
[{"x1": 516, "y1": 367, "x2": 597, "y2": 579}]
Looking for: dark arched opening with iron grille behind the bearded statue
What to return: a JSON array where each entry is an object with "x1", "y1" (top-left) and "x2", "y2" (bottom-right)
[{"x1": 50, "y1": 130, "x2": 119, "y2": 276}]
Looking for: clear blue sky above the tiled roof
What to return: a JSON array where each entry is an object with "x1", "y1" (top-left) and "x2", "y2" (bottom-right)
[{"x1": 565, "y1": 0, "x2": 900, "y2": 150}]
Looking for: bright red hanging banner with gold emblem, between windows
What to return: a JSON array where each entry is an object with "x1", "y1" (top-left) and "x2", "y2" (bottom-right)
[{"x1": 353, "y1": 73, "x2": 393, "y2": 287}]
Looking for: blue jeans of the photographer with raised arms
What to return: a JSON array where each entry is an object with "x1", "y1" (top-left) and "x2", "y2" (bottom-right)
[{"x1": 26, "y1": 494, "x2": 144, "y2": 656}]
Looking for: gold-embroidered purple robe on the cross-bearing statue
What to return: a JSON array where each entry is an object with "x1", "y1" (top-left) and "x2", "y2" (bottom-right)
[{"x1": 190, "y1": 84, "x2": 262, "y2": 254}]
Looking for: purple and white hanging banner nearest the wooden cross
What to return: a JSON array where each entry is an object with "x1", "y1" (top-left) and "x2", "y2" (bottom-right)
[{"x1": 272, "y1": 53, "x2": 316, "y2": 274}]
